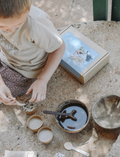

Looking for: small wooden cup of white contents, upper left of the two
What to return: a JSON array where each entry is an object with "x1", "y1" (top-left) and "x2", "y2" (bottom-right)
[{"x1": 27, "y1": 115, "x2": 43, "y2": 132}]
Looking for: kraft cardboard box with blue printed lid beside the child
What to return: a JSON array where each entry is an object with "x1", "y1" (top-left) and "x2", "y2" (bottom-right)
[{"x1": 60, "y1": 26, "x2": 109, "y2": 84}]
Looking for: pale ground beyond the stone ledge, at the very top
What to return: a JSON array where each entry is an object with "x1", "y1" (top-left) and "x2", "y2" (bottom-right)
[{"x1": 33, "y1": 0, "x2": 93, "y2": 28}]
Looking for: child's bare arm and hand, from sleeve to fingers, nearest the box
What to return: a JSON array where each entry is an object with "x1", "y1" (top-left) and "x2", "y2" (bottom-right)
[{"x1": 26, "y1": 41, "x2": 65, "y2": 102}]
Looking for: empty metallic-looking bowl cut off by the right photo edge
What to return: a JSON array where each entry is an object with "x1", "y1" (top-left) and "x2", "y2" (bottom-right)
[{"x1": 92, "y1": 95, "x2": 120, "y2": 129}]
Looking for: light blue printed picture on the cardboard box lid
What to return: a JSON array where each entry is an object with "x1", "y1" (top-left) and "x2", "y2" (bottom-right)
[{"x1": 61, "y1": 31, "x2": 100, "y2": 74}]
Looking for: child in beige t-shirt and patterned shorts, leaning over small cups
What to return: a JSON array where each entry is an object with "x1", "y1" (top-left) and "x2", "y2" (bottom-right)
[{"x1": 0, "y1": 0, "x2": 65, "y2": 105}]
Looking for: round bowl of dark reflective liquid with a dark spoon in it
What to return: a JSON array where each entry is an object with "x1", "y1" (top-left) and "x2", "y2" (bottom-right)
[{"x1": 55, "y1": 100, "x2": 90, "y2": 133}]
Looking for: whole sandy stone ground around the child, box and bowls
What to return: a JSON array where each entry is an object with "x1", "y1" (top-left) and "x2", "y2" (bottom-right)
[{"x1": 0, "y1": 0, "x2": 120, "y2": 157}]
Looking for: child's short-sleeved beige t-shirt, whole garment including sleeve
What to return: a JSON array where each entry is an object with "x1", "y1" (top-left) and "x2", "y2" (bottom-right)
[{"x1": 0, "y1": 6, "x2": 63, "y2": 78}]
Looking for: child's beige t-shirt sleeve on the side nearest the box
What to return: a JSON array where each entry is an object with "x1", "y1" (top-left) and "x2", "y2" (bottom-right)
[{"x1": 31, "y1": 13, "x2": 63, "y2": 53}]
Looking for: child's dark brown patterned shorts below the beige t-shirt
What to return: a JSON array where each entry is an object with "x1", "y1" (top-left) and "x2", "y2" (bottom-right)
[{"x1": 0, "y1": 61, "x2": 36, "y2": 97}]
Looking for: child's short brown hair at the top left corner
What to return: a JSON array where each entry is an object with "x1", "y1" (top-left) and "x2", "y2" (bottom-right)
[{"x1": 0, "y1": 0, "x2": 32, "y2": 18}]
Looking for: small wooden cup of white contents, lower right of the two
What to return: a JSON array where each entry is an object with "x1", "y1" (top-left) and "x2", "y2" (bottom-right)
[{"x1": 37, "y1": 127, "x2": 53, "y2": 144}]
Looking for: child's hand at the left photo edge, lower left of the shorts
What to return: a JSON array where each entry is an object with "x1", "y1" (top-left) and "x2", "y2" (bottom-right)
[{"x1": 0, "y1": 84, "x2": 17, "y2": 105}]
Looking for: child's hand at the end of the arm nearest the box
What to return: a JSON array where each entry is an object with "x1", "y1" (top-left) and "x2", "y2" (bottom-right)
[{"x1": 26, "y1": 79, "x2": 47, "y2": 102}]
